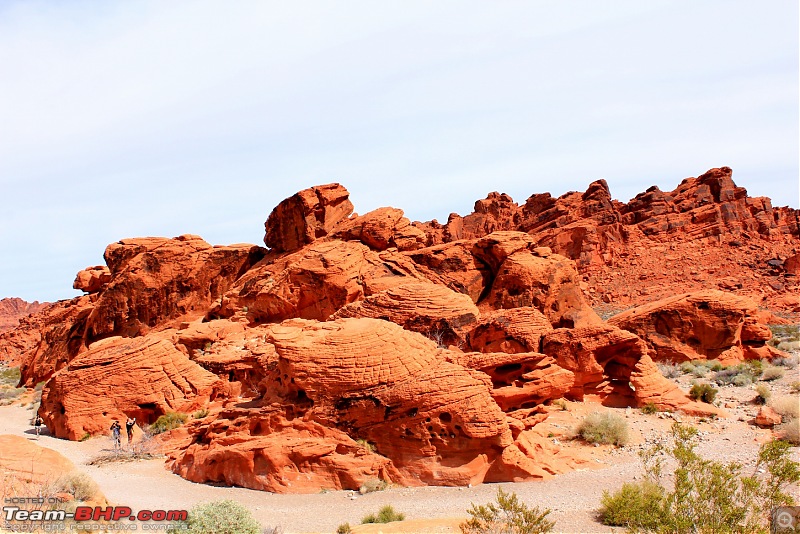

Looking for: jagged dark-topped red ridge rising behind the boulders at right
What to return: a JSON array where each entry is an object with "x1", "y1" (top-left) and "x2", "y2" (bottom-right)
[{"x1": 415, "y1": 167, "x2": 800, "y2": 312}]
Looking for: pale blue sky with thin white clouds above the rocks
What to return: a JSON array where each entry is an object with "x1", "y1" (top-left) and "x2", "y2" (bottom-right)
[{"x1": 0, "y1": 0, "x2": 800, "y2": 301}]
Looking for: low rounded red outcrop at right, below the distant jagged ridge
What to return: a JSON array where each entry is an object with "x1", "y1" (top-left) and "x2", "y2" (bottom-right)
[{"x1": 609, "y1": 290, "x2": 778, "y2": 365}]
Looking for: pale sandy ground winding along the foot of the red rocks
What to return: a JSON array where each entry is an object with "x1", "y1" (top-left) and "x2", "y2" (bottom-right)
[{"x1": 0, "y1": 369, "x2": 800, "y2": 534}]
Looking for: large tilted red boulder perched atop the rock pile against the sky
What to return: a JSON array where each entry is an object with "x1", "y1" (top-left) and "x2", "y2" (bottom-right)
[{"x1": 264, "y1": 184, "x2": 353, "y2": 252}]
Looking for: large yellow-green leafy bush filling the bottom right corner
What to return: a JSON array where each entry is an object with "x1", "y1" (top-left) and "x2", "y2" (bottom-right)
[{"x1": 600, "y1": 423, "x2": 800, "y2": 533}]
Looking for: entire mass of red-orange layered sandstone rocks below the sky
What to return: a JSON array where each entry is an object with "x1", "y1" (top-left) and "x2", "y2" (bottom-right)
[{"x1": 0, "y1": 168, "x2": 798, "y2": 492}]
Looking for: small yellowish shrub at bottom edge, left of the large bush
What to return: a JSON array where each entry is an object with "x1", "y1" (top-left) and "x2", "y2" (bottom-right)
[{"x1": 459, "y1": 488, "x2": 555, "y2": 534}]
